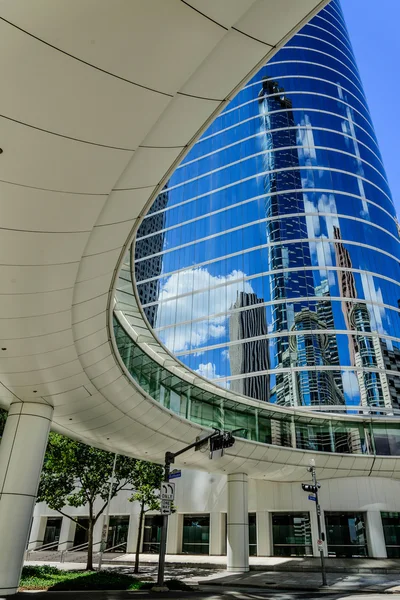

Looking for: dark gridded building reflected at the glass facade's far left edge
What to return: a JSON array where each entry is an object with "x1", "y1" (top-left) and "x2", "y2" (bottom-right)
[{"x1": 132, "y1": 192, "x2": 168, "y2": 327}]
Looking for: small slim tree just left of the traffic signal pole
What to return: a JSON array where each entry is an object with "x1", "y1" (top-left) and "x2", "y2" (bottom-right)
[{"x1": 129, "y1": 460, "x2": 164, "y2": 573}]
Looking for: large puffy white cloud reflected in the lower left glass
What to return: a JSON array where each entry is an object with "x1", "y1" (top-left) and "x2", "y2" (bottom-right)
[{"x1": 156, "y1": 268, "x2": 253, "y2": 352}]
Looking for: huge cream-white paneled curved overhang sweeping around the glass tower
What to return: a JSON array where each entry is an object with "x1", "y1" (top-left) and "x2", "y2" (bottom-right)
[{"x1": 0, "y1": 0, "x2": 400, "y2": 481}]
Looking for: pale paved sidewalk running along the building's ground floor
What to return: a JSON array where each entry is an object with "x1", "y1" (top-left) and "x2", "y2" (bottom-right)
[{"x1": 26, "y1": 554, "x2": 400, "y2": 594}]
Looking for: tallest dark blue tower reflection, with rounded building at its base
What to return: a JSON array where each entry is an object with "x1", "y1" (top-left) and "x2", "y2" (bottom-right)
[{"x1": 258, "y1": 80, "x2": 344, "y2": 406}]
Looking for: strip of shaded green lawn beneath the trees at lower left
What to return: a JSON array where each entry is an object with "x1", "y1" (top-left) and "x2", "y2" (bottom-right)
[{"x1": 19, "y1": 565, "x2": 191, "y2": 591}]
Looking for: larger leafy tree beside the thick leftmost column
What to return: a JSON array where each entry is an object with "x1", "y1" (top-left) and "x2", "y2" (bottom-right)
[{"x1": 37, "y1": 433, "x2": 137, "y2": 571}]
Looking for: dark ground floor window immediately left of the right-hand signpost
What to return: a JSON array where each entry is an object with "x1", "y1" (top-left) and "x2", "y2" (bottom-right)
[{"x1": 272, "y1": 513, "x2": 313, "y2": 556}]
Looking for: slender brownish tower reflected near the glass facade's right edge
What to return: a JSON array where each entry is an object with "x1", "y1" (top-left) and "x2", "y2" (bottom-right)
[{"x1": 333, "y1": 227, "x2": 391, "y2": 408}]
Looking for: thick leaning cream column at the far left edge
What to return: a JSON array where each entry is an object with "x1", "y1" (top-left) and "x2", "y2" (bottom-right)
[{"x1": 0, "y1": 402, "x2": 53, "y2": 597}]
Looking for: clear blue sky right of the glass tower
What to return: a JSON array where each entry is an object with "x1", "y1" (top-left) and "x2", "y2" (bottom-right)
[{"x1": 341, "y1": 0, "x2": 400, "y2": 215}]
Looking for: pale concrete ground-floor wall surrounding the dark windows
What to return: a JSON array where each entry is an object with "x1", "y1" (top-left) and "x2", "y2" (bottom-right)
[{"x1": 29, "y1": 470, "x2": 400, "y2": 557}]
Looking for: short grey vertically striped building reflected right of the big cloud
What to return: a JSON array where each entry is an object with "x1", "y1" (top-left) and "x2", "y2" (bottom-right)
[{"x1": 229, "y1": 292, "x2": 269, "y2": 401}]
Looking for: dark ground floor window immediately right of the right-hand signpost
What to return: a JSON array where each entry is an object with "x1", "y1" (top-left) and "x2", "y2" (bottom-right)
[{"x1": 325, "y1": 512, "x2": 368, "y2": 558}]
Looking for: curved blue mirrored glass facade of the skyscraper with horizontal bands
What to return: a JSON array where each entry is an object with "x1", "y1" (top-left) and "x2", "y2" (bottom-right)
[{"x1": 132, "y1": 0, "x2": 400, "y2": 410}]
